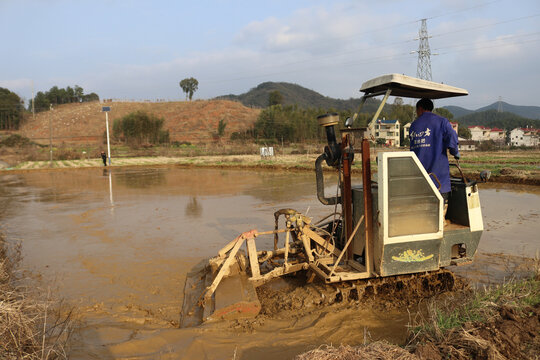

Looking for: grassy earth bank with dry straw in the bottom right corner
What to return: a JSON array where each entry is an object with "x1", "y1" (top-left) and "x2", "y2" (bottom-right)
[{"x1": 296, "y1": 271, "x2": 540, "y2": 360}]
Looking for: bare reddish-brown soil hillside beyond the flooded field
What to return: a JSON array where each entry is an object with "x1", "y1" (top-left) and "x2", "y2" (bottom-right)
[{"x1": 21, "y1": 100, "x2": 260, "y2": 144}]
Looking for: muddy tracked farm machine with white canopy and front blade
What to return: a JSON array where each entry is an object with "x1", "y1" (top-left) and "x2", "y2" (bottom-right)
[{"x1": 180, "y1": 74, "x2": 483, "y2": 327}]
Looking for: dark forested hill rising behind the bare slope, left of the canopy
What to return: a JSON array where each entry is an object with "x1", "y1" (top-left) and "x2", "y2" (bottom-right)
[{"x1": 216, "y1": 82, "x2": 380, "y2": 112}]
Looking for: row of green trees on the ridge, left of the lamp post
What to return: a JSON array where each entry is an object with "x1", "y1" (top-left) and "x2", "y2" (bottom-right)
[{"x1": 28, "y1": 85, "x2": 99, "y2": 112}]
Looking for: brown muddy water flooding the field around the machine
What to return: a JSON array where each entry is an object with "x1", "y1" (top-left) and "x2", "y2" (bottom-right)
[{"x1": 0, "y1": 168, "x2": 540, "y2": 360}]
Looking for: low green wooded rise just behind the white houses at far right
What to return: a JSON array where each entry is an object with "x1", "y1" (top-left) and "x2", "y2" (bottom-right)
[{"x1": 454, "y1": 110, "x2": 540, "y2": 130}]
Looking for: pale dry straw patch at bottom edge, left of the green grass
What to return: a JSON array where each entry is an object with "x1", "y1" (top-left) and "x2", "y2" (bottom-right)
[{"x1": 295, "y1": 341, "x2": 418, "y2": 360}]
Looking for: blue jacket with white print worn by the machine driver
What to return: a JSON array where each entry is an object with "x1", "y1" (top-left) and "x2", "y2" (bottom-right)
[{"x1": 409, "y1": 111, "x2": 459, "y2": 193}]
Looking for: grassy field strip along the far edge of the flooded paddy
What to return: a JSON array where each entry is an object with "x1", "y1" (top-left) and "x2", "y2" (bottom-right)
[{"x1": 4, "y1": 144, "x2": 540, "y2": 185}]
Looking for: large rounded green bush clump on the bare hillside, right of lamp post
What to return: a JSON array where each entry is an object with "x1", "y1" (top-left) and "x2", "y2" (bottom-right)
[{"x1": 113, "y1": 111, "x2": 169, "y2": 147}]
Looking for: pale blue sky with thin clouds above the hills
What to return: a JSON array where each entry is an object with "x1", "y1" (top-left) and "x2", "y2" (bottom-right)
[{"x1": 0, "y1": 0, "x2": 540, "y2": 109}]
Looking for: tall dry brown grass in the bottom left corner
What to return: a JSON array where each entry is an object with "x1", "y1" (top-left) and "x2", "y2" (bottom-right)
[{"x1": 0, "y1": 235, "x2": 74, "y2": 359}]
